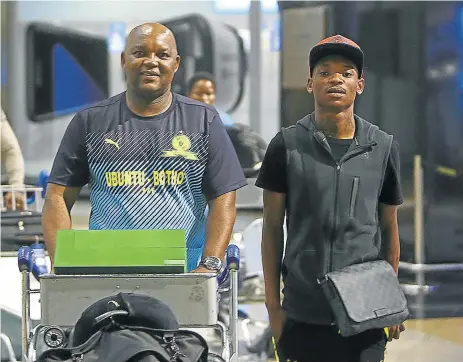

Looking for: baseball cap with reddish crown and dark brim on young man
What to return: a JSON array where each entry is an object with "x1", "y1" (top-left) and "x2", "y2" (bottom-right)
[{"x1": 309, "y1": 35, "x2": 363, "y2": 75}]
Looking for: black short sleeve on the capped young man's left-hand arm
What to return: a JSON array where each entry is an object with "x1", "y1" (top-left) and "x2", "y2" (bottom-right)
[{"x1": 256, "y1": 131, "x2": 288, "y2": 194}]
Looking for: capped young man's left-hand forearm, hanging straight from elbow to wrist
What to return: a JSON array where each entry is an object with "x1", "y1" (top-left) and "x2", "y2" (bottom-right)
[{"x1": 261, "y1": 224, "x2": 283, "y2": 309}]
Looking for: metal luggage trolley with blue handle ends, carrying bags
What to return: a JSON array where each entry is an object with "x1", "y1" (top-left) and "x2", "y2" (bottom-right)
[{"x1": 18, "y1": 244, "x2": 240, "y2": 362}]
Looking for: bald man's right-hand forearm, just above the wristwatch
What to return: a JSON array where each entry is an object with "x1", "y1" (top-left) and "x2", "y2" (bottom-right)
[{"x1": 203, "y1": 195, "x2": 236, "y2": 259}]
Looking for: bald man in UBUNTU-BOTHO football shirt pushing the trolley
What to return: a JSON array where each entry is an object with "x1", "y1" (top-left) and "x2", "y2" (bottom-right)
[{"x1": 43, "y1": 23, "x2": 246, "y2": 272}]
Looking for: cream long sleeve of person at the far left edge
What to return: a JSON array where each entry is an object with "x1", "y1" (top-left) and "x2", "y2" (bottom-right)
[{"x1": 1, "y1": 109, "x2": 25, "y2": 186}]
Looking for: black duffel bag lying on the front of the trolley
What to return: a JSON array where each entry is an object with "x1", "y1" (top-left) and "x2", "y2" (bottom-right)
[{"x1": 36, "y1": 293, "x2": 221, "y2": 362}]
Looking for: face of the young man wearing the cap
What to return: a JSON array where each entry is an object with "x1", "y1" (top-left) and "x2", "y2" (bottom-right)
[{"x1": 307, "y1": 56, "x2": 365, "y2": 110}]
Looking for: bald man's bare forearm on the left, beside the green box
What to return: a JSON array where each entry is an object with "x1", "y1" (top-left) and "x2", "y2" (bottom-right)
[{"x1": 42, "y1": 195, "x2": 72, "y2": 265}]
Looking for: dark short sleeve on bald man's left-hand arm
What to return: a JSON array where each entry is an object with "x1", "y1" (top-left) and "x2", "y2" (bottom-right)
[{"x1": 49, "y1": 113, "x2": 90, "y2": 187}]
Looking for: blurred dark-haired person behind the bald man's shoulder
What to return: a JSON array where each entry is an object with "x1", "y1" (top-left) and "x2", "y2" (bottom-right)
[{"x1": 188, "y1": 72, "x2": 234, "y2": 126}]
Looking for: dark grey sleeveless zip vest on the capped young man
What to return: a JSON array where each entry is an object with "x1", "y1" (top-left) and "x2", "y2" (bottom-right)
[{"x1": 283, "y1": 114, "x2": 392, "y2": 324}]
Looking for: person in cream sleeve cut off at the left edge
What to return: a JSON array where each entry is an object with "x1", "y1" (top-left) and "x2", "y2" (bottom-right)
[{"x1": 1, "y1": 108, "x2": 25, "y2": 210}]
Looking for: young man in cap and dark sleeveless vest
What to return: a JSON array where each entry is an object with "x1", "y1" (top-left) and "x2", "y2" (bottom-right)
[{"x1": 256, "y1": 35, "x2": 403, "y2": 362}]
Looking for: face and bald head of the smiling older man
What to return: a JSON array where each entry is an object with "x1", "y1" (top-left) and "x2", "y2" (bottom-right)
[{"x1": 121, "y1": 27, "x2": 180, "y2": 95}]
